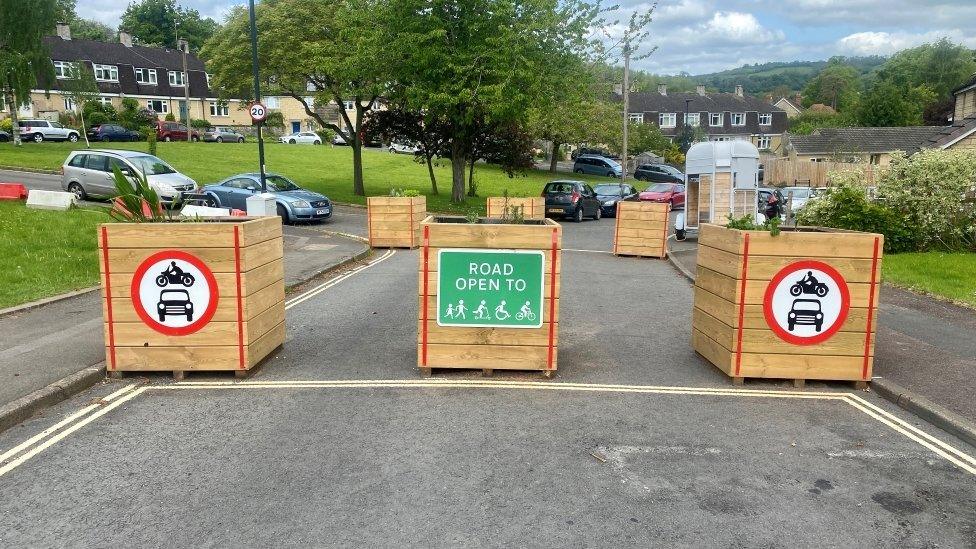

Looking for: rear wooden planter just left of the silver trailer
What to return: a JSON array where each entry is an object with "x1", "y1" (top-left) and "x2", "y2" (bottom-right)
[{"x1": 613, "y1": 201, "x2": 671, "y2": 259}]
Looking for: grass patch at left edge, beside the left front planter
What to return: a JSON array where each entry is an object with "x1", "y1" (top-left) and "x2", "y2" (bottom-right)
[{"x1": 0, "y1": 201, "x2": 110, "y2": 308}]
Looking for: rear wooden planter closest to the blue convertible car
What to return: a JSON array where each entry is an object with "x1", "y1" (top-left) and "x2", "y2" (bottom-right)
[{"x1": 366, "y1": 196, "x2": 427, "y2": 248}]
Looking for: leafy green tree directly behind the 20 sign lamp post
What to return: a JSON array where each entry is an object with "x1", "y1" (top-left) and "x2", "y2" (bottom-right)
[{"x1": 201, "y1": 0, "x2": 388, "y2": 196}]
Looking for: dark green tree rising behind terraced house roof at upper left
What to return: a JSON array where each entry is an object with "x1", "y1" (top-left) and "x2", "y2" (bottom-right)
[{"x1": 119, "y1": 0, "x2": 216, "y2": 50}]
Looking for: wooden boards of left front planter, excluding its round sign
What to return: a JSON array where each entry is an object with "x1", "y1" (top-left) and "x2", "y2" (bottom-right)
[{"x1": 99, "y1": 217, "x2": 285, "y2": 372}]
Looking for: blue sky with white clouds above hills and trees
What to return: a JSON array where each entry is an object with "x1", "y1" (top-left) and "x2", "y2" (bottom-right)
[{"x1": 77, "y1": 0, "x2": 976, "y2": 74}]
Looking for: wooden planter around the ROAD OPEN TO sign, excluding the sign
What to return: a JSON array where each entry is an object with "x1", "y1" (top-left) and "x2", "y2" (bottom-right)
[{"x1": 417, "y1": 217, "x2": 562, "y2": 377}]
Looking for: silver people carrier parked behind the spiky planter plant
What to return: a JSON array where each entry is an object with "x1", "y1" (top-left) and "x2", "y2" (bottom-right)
[{"x1": 61, "y1": 149, "x2": 197, "y2": 204}]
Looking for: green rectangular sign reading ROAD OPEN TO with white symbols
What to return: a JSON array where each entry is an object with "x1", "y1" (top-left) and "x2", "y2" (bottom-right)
[{"x1": 437, "y1": 249, "x2": 545, "y2": 328}]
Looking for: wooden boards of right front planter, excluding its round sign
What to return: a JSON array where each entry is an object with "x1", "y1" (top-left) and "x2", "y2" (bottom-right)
[{"x1": 692, "y1": 220, "x2": 884, "y2": 382}]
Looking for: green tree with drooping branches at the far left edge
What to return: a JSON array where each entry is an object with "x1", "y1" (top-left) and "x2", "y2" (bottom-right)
[{"x1": 0, "y1": 0, "x2": 57, "y2": 146}]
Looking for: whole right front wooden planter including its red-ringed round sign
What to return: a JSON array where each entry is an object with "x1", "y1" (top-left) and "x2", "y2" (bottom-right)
[{"x1": 692, "y1": 224, "x2": 884, "y2": 385}]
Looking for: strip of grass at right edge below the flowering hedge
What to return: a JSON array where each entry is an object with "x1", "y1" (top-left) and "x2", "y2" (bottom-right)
[{"x1": 882, "y1": 252, "x2": 976, "y2": 307}]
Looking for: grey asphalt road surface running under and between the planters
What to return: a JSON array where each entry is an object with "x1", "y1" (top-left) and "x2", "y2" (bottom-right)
[{"x1": 0, "y1": 197, "x2": 976, "y2": 547}]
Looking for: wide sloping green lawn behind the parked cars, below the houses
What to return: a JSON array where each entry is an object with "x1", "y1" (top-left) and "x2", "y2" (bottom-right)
[{"x1": 0, "y1": 143, "x2": 600, "y2": 212}]
